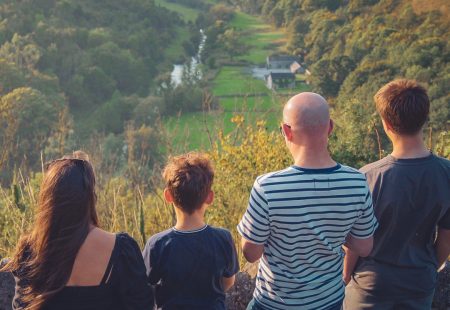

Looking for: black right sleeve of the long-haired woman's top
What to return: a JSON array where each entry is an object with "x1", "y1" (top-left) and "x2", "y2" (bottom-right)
[{"x1": 117, "y1": 235, "x2": 154, "y2": 310}]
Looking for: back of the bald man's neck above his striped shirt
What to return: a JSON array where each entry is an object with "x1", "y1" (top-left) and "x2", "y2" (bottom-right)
[{"x1": 291, "y1": 146, "x2": 336, "y2": 169}]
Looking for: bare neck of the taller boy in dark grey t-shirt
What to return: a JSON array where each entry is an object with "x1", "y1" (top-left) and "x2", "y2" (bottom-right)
[{"x1": 391, "y1": 135, "x2": 430, "y2": 159}]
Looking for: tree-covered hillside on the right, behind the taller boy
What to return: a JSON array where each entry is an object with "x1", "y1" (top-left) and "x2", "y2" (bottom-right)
[{"x1": 230, "y1": 0, "x2": 450, "y2": 165}]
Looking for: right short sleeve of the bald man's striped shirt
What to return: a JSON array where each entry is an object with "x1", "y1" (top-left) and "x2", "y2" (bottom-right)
[{"x1": 350, "y1": 184, "x2": 378, "y2": 239}]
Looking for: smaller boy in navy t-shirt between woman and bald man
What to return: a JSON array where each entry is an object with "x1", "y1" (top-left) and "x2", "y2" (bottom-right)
[{"x1": 143, "y1": 153, "x2": 239, "y2": 310}]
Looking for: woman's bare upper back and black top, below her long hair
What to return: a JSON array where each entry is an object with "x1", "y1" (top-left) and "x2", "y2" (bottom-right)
[{"x1": 13, "y1": 228, "x2": 153, "y2": 310}]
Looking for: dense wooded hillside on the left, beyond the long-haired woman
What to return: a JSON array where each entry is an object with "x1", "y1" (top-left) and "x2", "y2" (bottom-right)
[{"x1": 0, "y1": 0, "x2": 183, "y2": 181}]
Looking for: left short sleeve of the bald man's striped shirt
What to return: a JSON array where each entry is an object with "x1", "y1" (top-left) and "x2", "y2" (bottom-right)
[{"x1": 237, "y1": 180, "x2": 270, "y2": 244}]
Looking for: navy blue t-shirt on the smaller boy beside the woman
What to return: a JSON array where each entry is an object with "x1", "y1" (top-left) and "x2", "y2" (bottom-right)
[{"x1": 143, "y1": 225, "x2": 239, "y2": 310}]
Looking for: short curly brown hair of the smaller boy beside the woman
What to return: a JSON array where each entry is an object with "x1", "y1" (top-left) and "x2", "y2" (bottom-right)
[{"x1": 163, "y1": 153, "x2": 214, "y2": 214}]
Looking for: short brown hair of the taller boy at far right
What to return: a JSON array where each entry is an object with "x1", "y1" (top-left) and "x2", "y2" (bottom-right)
[{"x1": 374, "y1": 80, "x2": 430, "y2": 135}]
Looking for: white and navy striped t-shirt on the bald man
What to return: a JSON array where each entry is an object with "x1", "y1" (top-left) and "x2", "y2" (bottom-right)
[{"x1": 237, "y1": 164, "x2": 378, "y2": 309}]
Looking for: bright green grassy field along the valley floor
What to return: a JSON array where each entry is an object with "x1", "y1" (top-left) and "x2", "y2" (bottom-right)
[{"x1": 158, "y1": 6, "x2": 308, "y2": 151}]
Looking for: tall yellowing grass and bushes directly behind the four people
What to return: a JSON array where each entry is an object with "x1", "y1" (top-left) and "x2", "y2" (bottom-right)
[{"x1": 0, "y1": 122, "x2": 450, "y2": 264}]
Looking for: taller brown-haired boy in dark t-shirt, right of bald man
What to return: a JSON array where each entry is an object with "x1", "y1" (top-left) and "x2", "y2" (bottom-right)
[{"x1": 344, "y1": 80, "x2": 450, "y2": 309}]
